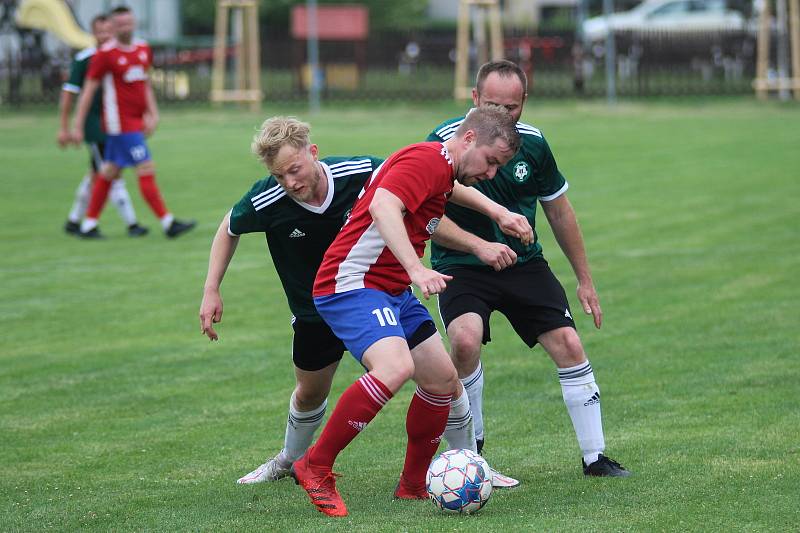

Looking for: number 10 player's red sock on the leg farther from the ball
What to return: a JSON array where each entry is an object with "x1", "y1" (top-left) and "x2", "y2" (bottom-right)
[{"x1": 308, "y1": 374, "x2": 392, "y2": 468}]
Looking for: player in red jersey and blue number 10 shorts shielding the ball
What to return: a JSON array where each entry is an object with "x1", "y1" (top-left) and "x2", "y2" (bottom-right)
[{"x1": 291, "y1": 107, "x2": 533, "y2": 516}]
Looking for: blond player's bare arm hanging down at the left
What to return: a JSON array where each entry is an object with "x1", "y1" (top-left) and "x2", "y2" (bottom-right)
[{"x1": 200, "y1": 212, "x2": 239, "y2": 341}]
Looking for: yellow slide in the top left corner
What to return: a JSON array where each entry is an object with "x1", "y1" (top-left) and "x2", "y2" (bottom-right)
[{"x1": 17, "y1": 0, "x2": 96, "y2": 48}]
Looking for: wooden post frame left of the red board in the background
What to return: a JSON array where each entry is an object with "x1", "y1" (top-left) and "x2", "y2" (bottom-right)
[{"x1": 210, "y1": 0, "x2": 263, "y2": 112}]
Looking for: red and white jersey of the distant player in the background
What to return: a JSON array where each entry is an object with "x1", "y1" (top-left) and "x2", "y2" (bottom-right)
[{"x1": 87, "y1": 39, "x2": 153, "y2": 135}]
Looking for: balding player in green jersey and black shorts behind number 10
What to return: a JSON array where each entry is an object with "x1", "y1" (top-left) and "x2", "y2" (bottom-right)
[{"x1": 427, "y1": 61, "x2": 629, "y2": 476}]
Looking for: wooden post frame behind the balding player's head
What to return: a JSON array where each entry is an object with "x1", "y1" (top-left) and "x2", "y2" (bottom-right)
[{"x1": 453, "y1": 0, "x2": 503, "y2": 100}]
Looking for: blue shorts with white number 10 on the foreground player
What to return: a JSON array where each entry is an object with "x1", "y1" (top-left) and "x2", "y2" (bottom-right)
[{"x1": 314, "y1": 289, "x2": 433, "y2": 363}]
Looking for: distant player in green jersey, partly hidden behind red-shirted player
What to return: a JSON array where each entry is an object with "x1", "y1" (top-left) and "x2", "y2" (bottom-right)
[{"x1": 58, "y1": 14, "x2": 147, "y2": 237}]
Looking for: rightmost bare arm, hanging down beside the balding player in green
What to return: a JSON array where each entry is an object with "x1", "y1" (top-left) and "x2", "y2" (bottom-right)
[{"x1": 542, "y1": 194, "x2": 603, "y2": 329}]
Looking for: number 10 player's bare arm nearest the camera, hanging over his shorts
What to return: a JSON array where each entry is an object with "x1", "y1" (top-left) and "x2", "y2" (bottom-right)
[{"x1": 369, "y1": 188, "x2": 453, "y2": 299}]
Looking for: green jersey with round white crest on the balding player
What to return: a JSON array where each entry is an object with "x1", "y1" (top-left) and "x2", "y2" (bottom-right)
[{"x1": 427, "y1": 117, "x2": 568, "y2": 272}]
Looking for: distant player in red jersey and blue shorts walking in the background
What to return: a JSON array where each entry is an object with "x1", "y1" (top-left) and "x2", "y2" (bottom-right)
[{"x1": 72, "y1": 7, "x2": 195, "y2": 238}]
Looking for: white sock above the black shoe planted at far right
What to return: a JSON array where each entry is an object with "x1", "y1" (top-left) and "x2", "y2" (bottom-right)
[{"x1": 558, "y1": 361, "x2": 606, "y2": 465}]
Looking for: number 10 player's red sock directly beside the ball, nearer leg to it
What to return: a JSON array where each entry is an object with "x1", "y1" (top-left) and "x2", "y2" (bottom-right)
[{"x1": 403, "y1": 387, "x2": 453, "y2": 488}]
